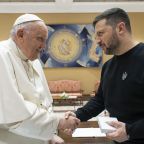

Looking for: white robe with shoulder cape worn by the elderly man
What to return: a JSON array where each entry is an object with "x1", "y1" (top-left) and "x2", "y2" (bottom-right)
[{"x1": 0, "y1": 39, "x2": 59, "y2": 144}]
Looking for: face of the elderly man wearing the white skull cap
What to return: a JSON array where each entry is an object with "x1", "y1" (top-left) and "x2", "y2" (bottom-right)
[{"x1": 20, "y1": 21, "x2": 48, "y2": 60}]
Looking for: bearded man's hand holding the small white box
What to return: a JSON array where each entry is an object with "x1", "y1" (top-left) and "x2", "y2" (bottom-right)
[{"x1": 106, "y1": 121, "x2": 128, "y2": 142}]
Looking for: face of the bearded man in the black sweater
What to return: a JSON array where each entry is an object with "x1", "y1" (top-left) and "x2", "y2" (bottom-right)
[{"x1": 95, "y1": 19, "x2": 120, "y2": 54}]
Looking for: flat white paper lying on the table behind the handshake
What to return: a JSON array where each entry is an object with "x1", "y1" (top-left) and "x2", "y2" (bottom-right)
[{"x1": 72, "y1": 128, "x2": 106, "y2": 137}]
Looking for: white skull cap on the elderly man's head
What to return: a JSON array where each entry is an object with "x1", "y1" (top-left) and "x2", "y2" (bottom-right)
[{"x1": 13, "y1": 14, "x2": 43, "y2": 26}]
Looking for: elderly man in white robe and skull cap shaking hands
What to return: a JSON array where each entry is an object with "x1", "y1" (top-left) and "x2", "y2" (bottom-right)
[{"x1": 0, "y1": 14, "x2": 79, "y2": 144}]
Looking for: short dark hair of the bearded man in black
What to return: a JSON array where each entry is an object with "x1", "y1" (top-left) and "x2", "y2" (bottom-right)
[{"x1": 93, "y1": 8, "x2": 131, "y2": 33}]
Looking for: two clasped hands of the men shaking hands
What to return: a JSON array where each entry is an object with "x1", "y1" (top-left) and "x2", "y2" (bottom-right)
[{"x1": 58, "y1": 111, "x2": 80, "y2": 135}]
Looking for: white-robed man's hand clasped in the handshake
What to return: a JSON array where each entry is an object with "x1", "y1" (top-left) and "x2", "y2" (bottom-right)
[{"x1": 58, "y1": 116, "x2": 80, "y2": 131}]
